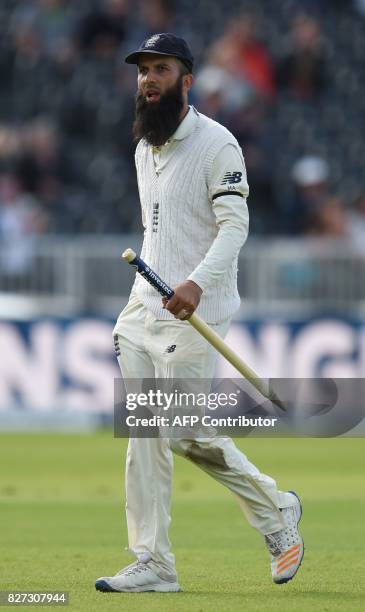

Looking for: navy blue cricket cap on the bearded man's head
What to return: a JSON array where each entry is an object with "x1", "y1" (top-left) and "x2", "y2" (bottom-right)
[{"x1": 125, "y1": 32, "x2": 194, "y2": 72}]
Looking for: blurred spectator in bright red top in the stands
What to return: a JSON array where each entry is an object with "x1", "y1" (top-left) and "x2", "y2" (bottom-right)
[{"x1": 207, "y1": 14, "x2": 276, "y2": 99}]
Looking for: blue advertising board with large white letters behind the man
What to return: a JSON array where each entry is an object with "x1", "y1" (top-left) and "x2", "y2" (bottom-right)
[{"x1": 0, "y1": 317, "x2": 365, "y2": 414}]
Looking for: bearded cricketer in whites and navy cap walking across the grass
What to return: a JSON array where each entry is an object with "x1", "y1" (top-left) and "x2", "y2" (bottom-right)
[{"x1": 96, "y1": 33, "x2": 303, "y2": 592}]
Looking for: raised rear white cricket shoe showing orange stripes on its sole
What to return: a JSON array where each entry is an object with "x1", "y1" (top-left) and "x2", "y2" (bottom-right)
[{"x1": 265, "y1": 491, "x2": 304, "y2": 584}]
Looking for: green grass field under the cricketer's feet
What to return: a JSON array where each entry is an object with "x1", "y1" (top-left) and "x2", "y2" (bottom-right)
[{"x1": 0, "y1": 432, "x2": 365, "y2": 612}]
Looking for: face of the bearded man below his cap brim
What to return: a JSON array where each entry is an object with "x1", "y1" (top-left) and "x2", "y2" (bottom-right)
[{"x1": 138, "y1": 53, "x2": 180, "y2": 104}]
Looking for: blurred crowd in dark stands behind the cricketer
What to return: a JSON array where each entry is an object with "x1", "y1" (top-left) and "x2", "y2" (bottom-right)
[{"x1": 0, "y1": 0, "x2": 365, "y2": 251}]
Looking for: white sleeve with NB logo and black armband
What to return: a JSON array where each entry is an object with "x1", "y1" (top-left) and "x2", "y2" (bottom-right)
[{"x1": 188, "y1": 143, "x2": 249, "y2": 291}]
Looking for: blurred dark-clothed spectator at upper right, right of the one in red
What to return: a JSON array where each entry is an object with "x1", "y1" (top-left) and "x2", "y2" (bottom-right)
[{"x1": 277, "y1": 15, "x2": 327, "y2": 101}]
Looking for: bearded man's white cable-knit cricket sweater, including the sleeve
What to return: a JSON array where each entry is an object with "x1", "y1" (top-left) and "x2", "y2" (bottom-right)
[{"x1": 132, "y1": 107, "x2": 248, "y2": 323}]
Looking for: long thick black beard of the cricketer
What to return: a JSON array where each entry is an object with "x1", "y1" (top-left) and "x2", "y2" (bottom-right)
[{"x1": 133, "y1": 75, "x2": 184, "y2": 147}]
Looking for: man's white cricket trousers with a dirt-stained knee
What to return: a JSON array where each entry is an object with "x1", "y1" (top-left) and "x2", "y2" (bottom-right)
[{"x1": 113, "y1": 296, "x2": 293, "y2": 573}]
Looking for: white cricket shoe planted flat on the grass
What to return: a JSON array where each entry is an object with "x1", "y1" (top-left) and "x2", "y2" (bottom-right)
[{"x1": 95, "y1": 561, "x2": 181, "y2": 593}]
